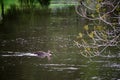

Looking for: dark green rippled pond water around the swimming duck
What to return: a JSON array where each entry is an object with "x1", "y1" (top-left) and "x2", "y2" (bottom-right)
[{"x1": 0, "y1": 8, "x2": 120, "y2": 80}]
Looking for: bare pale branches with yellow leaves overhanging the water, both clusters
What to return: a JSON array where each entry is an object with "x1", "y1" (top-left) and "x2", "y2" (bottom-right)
[{"x1": 74, "y1": 0, "x2": 120, "y2": 57}]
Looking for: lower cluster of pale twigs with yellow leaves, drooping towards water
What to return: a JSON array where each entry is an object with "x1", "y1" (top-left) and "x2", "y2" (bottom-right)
[{"x1": 74, "y1": 25, "x2": 120, "y2": 57}]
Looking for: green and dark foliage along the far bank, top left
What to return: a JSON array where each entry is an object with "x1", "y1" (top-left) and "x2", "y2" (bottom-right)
[{"x1": 0, "y1": 0, "x2": 51, "y2": 21}]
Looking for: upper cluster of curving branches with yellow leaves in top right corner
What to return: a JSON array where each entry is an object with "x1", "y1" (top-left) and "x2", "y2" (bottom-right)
[{"x1": 75, "y1": 0, "x2": 120, "y2": 26}]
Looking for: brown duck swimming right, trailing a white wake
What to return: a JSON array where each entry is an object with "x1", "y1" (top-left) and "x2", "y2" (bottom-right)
[{"x1": 34, "y1": 50, "x2": 52, "y2": 60}]
